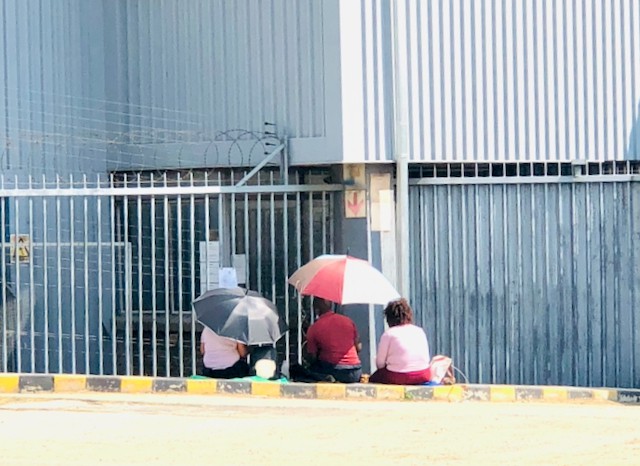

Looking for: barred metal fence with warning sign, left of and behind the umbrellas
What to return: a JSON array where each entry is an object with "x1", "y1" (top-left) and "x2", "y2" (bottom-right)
[{"x1": 0, "y1": 169, "x2": 342, "y2": 376}]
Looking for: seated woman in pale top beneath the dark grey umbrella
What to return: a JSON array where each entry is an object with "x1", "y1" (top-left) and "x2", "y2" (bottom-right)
[{"x1": 200, "y1": 327, "x2": 249, "y2": 379}]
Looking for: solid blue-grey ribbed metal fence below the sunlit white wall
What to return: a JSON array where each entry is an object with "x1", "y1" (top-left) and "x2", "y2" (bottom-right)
[{"x1": 410, "y1": 162, "x2": 640, "y2": 387}]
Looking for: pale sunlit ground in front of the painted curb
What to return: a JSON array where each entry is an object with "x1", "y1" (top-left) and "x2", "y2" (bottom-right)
[{"x1": 0, "y1": 394, "x2": 640, "y2": 466}]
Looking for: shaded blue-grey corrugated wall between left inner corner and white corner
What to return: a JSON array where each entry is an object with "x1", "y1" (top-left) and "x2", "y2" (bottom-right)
[{"x1": 105, "y1": 0, "x2": 325, "y2": 143}]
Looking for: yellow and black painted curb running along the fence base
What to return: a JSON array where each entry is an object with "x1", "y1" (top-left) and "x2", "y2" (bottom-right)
[{"x1": 0, "y1": 374, "x2": 640, "y2": 404}]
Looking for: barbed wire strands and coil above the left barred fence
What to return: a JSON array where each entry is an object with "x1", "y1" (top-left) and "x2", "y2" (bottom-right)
[{"x1": 0, "y1": 87, "x2": 283, "y2": 172}]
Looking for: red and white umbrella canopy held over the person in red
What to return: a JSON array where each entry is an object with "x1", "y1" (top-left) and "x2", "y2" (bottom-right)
[{"x1": 289, "y1": 254, "x2": 400, "y2": 304}]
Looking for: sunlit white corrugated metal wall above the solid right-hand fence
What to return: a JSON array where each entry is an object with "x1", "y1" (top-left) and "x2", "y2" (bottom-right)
[{"x1": 382, "y1": 0, "x2": 640, "y2": 161}]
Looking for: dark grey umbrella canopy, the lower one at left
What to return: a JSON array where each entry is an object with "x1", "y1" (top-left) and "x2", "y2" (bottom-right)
[{"x1": 193, "y1": 288, "x2": 287, "y2": 345}]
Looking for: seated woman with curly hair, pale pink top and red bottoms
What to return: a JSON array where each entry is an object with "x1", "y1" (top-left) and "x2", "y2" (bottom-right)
[{"x1": 369, "y1": 299, "x2": 431, "y2": 385}]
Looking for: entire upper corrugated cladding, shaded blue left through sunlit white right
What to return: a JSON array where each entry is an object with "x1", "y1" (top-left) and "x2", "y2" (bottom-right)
[{"x1": 5, "y1": 0, "x2": 640, "y2": 169}]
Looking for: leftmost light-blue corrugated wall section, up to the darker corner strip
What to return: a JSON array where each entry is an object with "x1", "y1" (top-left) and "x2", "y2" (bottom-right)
[{"x1": 0, "y1": 0, "x2": 105, "y2": 174}]
